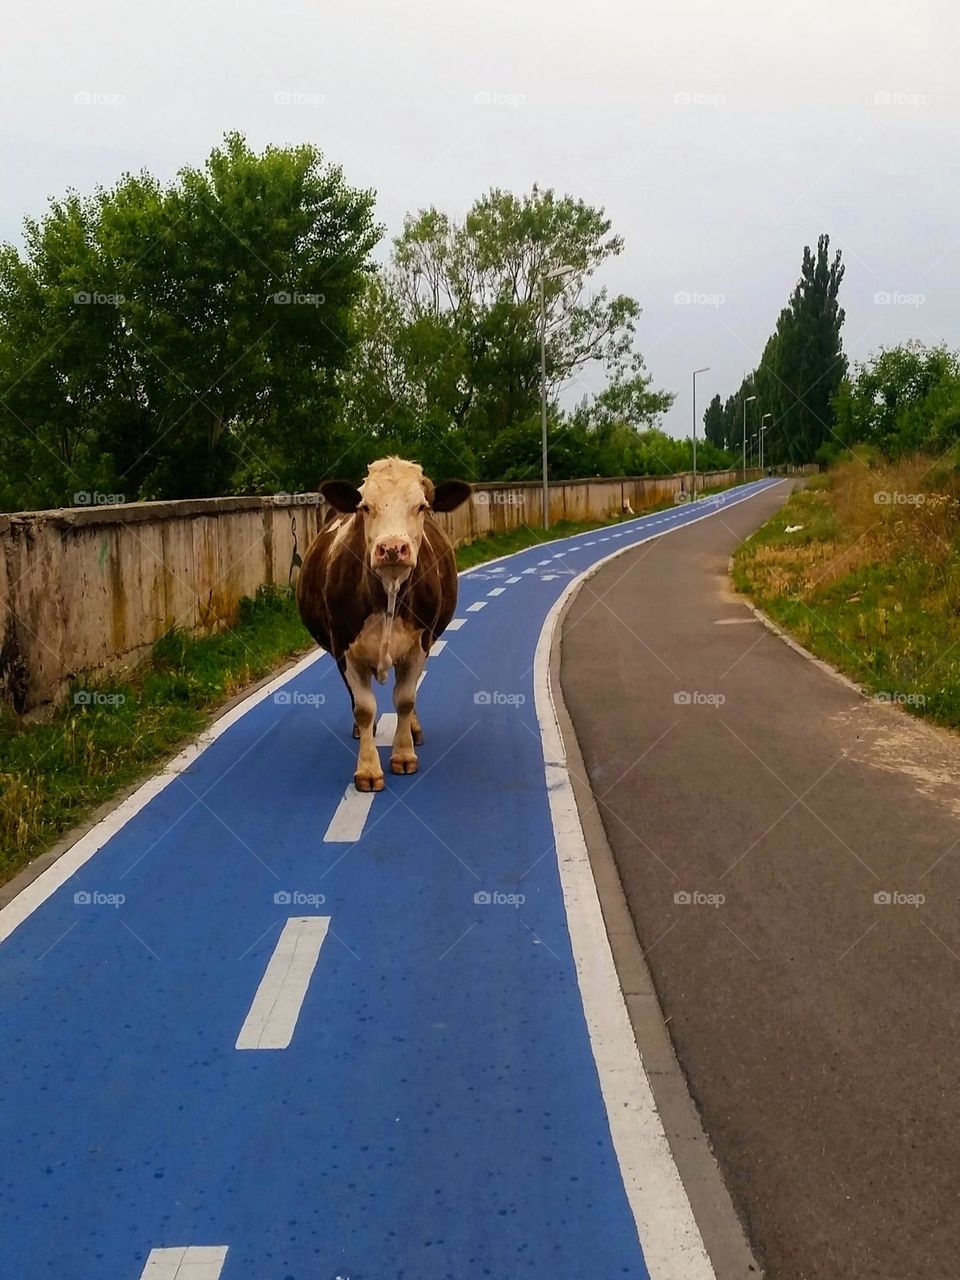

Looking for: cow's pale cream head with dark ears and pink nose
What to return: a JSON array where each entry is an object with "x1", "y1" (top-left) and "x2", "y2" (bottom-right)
[{"x1": 320, "y1": 458, "x2": 470, "y2": 580}]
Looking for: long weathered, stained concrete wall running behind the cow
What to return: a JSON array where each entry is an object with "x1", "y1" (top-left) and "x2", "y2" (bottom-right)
[{"x1": 0, "y1": 468, "x2": 815, "y2": 713}]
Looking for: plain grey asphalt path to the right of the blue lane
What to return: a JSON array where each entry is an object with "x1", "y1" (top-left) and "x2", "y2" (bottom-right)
[{"x1": 561, "y1": 484, "x2": 960, "y2": 1280}]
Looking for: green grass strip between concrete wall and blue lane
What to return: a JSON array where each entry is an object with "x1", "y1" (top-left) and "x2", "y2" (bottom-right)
[{"x1": 0, "y1": 478, "x2": 742, "y2": 883}]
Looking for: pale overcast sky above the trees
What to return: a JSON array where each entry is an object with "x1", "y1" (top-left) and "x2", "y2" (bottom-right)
[{"x1": 0, "y1": 0, "x2": 960, "y2": 434}]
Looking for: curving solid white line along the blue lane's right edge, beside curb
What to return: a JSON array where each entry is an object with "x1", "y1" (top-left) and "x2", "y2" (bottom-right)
[{"x1": 534, "y1": 485, "x2": 774, "y2": 1280}]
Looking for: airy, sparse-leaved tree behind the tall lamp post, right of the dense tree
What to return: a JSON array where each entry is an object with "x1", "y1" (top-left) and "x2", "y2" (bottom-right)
[{"x1": 343, "y1": 187, "x2": 671, "y2": 479}]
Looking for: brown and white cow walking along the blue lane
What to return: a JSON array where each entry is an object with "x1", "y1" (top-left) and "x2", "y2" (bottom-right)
[{"x1": 297, "y1": 458, "x2": 470, "y2": 791}]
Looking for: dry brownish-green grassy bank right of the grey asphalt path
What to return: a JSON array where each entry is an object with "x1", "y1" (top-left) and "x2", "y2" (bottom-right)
[{"x1": 733, "y1": 457, "x2": 960, "y2": 728}]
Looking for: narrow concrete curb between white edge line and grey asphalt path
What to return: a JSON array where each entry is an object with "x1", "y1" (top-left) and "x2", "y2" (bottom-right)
[{"x1": 550, "y1": 589, "x2": 763, "y2": 1280}]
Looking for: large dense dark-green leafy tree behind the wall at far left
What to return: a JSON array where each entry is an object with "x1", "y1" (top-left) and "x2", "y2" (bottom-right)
[{"x1": 0, "y1": 133, "x2": 379, "y2": 506}]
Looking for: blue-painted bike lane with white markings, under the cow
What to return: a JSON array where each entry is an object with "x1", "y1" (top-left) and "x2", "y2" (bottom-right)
[{"x1": 0, "y1": 481, "x2": 783, "y2": 1280}]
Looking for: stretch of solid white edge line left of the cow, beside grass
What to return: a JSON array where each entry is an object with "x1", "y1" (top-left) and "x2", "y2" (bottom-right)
[{"x1": 0, "y1": 649, "x2": 326, "y2": 942}]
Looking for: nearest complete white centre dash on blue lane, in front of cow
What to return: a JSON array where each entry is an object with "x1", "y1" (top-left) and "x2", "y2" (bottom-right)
[{"x1": 237, "y1": 921, "x2": 330, "y2": 1048}]
